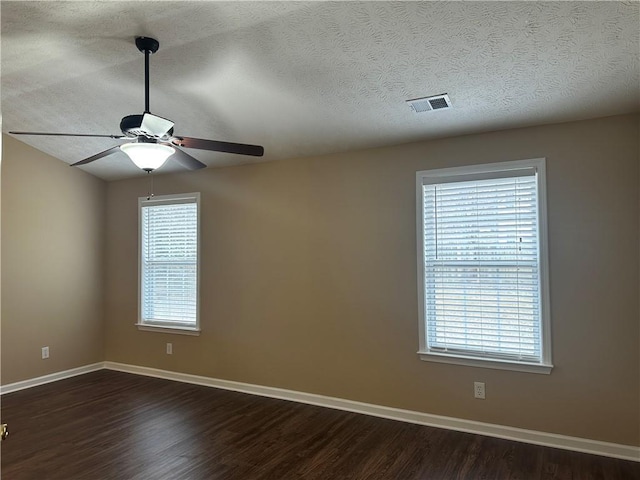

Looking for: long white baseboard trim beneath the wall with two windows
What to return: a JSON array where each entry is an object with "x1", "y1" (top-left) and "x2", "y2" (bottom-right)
[{"x1": 105, "y1": 362, "x2": 640, "y2": 462}]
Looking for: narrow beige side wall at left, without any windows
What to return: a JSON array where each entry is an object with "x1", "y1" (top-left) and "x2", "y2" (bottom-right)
[{"x1": 1, "y1": 136, "x2": 106, "y2": 385}]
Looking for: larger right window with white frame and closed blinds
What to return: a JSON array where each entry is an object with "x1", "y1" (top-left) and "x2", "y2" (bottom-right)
[{"x1": 417, "y1": 159, "x2": 552, "y2": 373}]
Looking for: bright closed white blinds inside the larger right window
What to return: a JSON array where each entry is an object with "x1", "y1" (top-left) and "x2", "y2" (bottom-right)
[{"x1": 422, "y1": 169, "x2": 542, "y2": 362}]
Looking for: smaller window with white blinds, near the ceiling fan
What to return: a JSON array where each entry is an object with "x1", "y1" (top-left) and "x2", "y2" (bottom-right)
[{"x1": 138, "y1": 193, "x2": 200, "y2": 334}]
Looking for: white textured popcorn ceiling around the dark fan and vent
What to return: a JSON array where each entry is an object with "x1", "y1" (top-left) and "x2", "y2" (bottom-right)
[{"x1": 1, "y1": 0, "x2": 640, "y2": 179}]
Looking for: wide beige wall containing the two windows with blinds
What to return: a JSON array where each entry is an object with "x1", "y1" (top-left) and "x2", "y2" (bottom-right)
[{"x1": 106, "y1": 115, "x2": 640, "y2": 445}]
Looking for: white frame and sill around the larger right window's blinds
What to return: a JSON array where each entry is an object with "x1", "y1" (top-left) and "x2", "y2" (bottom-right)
[{"x1": 416, "y1": 158, "x2": 553, "y2": 374}]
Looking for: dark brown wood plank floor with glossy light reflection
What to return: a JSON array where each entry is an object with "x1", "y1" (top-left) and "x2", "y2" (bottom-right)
[{"x1": 1, "y1": 370, "x2": 640, "y2": 480}]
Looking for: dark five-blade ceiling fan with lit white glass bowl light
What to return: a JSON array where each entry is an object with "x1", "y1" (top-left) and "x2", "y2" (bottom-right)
[{"x1": 9, "y1": 37, "x2": 264, "y2": 173}]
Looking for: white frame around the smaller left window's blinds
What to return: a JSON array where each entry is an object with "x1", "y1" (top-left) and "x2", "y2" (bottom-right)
[{"x1": 136, "y1": 192, "x2": 200, "y2": 335}]
